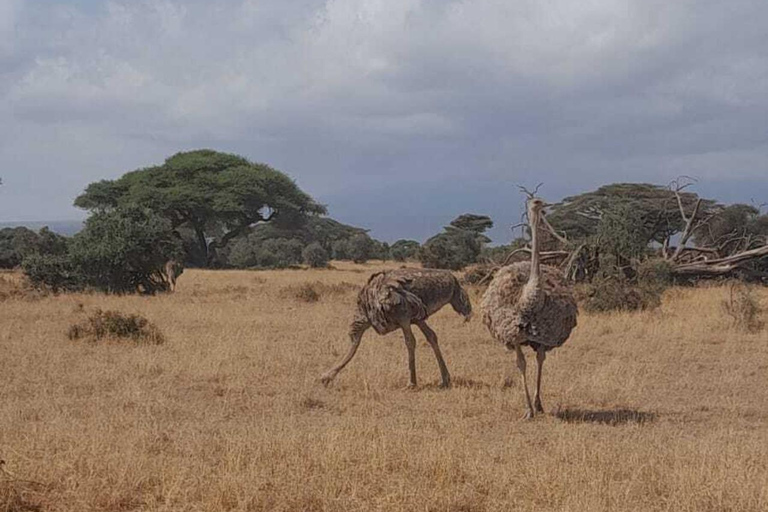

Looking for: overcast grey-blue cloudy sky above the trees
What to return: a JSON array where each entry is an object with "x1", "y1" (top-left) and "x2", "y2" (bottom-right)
[{"x1": 0, "y1": 0, "x2": 768, "y2": 242}]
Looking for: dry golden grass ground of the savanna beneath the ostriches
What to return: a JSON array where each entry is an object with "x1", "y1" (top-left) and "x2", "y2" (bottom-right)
[{"x1": 0, "y1": 264, "x2": 768, "y2": 512}]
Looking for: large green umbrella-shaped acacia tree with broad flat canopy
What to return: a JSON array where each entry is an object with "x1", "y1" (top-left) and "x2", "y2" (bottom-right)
[{"x1": 75, "y1": 149, "x2": 325, "y2": 266}]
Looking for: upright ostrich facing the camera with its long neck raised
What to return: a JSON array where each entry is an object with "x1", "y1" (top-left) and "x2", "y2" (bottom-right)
[{"x1": 482, "y1": 197, "x2": 578, "y2": 419}]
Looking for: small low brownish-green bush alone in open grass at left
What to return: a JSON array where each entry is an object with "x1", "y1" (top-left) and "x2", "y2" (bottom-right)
[{"x1": 67, "y1": 309, "x2": 165, "y2": 345}]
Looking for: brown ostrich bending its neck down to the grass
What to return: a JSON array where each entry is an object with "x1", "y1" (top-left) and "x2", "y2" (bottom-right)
[{"x1": 320, "y1": 268, "x2": 472, "y2": 387}]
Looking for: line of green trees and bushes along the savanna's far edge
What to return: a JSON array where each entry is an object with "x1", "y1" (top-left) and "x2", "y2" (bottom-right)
[{"x1": 0, "y1": 150, "x2": 768, "y2": 293}]
